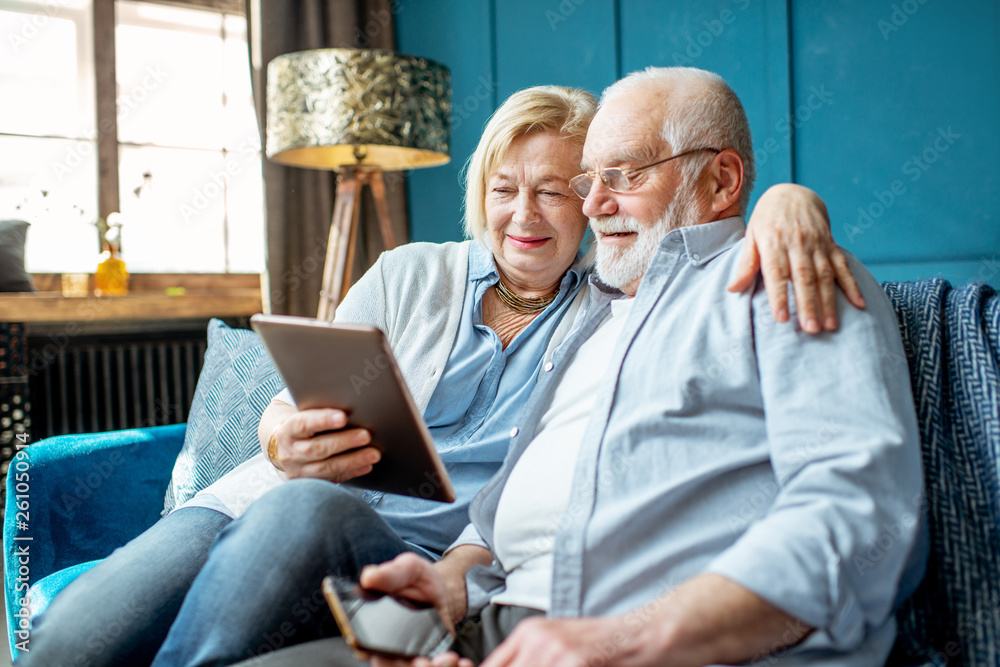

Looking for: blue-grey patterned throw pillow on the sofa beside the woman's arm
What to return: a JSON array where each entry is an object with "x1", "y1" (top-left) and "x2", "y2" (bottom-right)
[{"x1": 163, "y1": 319, "x2": 284, "y2": 514}]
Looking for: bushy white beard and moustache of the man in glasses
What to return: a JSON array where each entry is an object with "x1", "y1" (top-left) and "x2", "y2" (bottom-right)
[{"x1": 590, "y1": 188, "x2": 699, "y2": 289}]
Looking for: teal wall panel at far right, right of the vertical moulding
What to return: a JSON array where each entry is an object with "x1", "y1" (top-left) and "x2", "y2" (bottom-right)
[{"x1": 792, "y1": 0, "x2": 1000, "y2": 282}]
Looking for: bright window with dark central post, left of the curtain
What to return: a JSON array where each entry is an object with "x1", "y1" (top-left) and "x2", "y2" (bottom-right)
[{"x1": 0, "y1": 0, "x2": 264, "y2": 273}]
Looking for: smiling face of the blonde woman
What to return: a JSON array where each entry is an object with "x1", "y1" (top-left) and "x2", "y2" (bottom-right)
[{"x1": 486, "y1": 132, "x2": 587, "y2": 291}]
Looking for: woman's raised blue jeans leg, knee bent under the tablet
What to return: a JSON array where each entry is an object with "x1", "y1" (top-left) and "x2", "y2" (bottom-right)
[{"x1": 153, "y1": 479, "x2": 411, "y2": 667}]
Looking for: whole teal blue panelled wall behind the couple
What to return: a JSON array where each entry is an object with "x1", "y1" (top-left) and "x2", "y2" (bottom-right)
[{"x1": 396, "y1": 0, "x2": 1000, "y2": 285}]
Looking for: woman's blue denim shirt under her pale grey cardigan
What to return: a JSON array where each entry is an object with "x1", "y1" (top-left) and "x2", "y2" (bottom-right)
[{"x1": 362, "y1": 243, "x2": 587, "y2": 554}]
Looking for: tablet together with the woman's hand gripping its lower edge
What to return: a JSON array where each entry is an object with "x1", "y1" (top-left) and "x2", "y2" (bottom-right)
[{"x1": 250, "y1": 315, "x2": 455, "y2": 502}]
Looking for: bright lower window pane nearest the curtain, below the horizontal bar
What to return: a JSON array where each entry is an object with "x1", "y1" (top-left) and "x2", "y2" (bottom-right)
[{"x1": 119, "y1": 146, "x2": 229, "y2": 273}]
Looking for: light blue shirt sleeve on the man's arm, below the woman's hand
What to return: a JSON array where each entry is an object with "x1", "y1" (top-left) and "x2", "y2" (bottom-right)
[{"x1": 708, "y1": 258, "x2": 923, "y2": 649}]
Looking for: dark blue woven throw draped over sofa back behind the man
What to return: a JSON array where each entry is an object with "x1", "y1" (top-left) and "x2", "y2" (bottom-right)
[{"x1": 883, "y1": 279, "x2": 1000, "y2": 667}]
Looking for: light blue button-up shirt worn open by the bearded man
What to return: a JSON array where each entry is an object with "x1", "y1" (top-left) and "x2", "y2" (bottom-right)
[{"x1": 469, "y1": 218, "x2": 924, "y2": 665}]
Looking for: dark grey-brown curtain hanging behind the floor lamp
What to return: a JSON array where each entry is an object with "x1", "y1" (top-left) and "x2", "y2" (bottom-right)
[{"x1": 247, "y1": 0, "x2": 409, "y2": 317}]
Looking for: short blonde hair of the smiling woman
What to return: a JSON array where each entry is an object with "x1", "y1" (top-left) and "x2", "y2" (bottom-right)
[{"x1": 465, "y1": 86, "x2": 597, "y2": 243}]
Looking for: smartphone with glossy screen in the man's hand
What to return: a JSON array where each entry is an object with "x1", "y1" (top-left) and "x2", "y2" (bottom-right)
[{"x1": 323, "y1": 576, "x2": 455, "y2": 659}]
